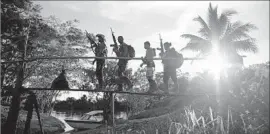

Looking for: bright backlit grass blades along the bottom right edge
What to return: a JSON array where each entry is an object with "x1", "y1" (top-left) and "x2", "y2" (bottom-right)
[{"x1": 168, "y1": 107, "x2": 269, "y2": 134}]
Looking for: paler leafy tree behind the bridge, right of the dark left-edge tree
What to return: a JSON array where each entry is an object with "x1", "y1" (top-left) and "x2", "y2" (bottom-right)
[{"x1": 25, "y1": 17, "x2": 87, "y2": 112}]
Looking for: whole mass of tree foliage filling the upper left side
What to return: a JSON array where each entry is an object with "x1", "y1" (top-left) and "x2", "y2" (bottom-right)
[{"x1": 1, "y1": 1, "x2": 90, "y2": 112}]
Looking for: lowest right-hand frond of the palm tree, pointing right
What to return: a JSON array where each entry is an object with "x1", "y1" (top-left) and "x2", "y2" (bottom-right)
[{"x1": 231, "y1": 38, "x2": 258, "y2": 53}]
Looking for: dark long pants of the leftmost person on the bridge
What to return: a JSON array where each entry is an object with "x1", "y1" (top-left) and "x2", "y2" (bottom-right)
[{"x1": 96, "y1": 59, "x2": 105, "y2": 89}]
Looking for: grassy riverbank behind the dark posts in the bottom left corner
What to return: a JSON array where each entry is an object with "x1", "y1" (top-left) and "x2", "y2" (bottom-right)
[{"x1": 1, "y1": 106, "x2": 66, "y2": 134}]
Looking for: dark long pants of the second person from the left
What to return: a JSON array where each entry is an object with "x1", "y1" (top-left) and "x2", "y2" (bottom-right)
[{"x1": 117, "y1": 60, "x2": 132, "y2": 91}]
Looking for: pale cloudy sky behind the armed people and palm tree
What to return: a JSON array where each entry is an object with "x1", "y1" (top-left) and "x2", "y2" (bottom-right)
[{"x1": 34, "y1": 1, "x2": 269, "y2": 99}]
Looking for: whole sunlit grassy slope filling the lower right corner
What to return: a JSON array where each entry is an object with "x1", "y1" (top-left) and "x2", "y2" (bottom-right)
[{"x1": 105, "y1": 64, "x2": 269, "y2": 134}]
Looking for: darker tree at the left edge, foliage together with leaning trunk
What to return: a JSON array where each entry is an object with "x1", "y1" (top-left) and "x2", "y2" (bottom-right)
[{"x1": 1, "y1": 0, "x2": 53, "y2": 133}]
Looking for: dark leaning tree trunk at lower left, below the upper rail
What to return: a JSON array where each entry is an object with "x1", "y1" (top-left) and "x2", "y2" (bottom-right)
[{"x1": 3, "y1": 63, "x2": 23, "y2": 134}]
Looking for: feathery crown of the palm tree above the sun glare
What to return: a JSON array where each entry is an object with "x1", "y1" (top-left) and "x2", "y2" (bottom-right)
[{"x1": 181, "y1": 3, "x2": 258, "y2": 65}]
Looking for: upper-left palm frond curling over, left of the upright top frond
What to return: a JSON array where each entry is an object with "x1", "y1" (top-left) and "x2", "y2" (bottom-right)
[{"x1": 193, "y1": 16, "x2": 211, "y2": 38}]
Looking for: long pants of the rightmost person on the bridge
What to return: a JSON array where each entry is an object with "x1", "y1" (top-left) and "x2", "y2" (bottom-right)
[{"x1": 163, "y1": 68, "x2": 178, "y2": 92}]
